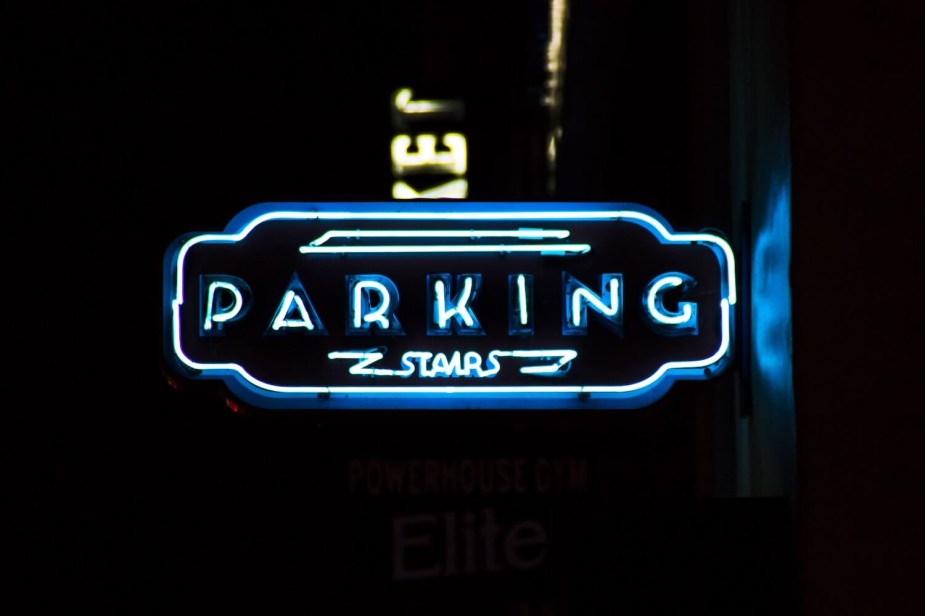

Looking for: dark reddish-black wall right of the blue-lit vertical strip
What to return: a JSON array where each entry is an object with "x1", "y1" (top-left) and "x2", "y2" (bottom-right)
[{"x1": 791, "y1": 0, "x2": 925, "y2": 614}]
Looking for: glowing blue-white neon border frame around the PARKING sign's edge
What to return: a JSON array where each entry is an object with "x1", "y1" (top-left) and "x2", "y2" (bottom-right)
[{"x1": 163, "y1": 200, "x2": 736, "y2": 410}]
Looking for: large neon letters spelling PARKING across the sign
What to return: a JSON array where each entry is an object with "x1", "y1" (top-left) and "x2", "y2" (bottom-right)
[{"x1": 200, "y1": 272, "x2": 697, "y2": 336}]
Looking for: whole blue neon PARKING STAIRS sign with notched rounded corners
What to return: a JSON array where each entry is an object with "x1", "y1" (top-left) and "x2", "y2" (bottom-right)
[{"x1": 164, "y1": 201, "x2": 736, "y2": 410}]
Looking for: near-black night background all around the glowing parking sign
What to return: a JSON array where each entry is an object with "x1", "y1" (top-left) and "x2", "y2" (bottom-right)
[{"x1": 2, "y1": 0, "x2": 925, "y2": 614}]
